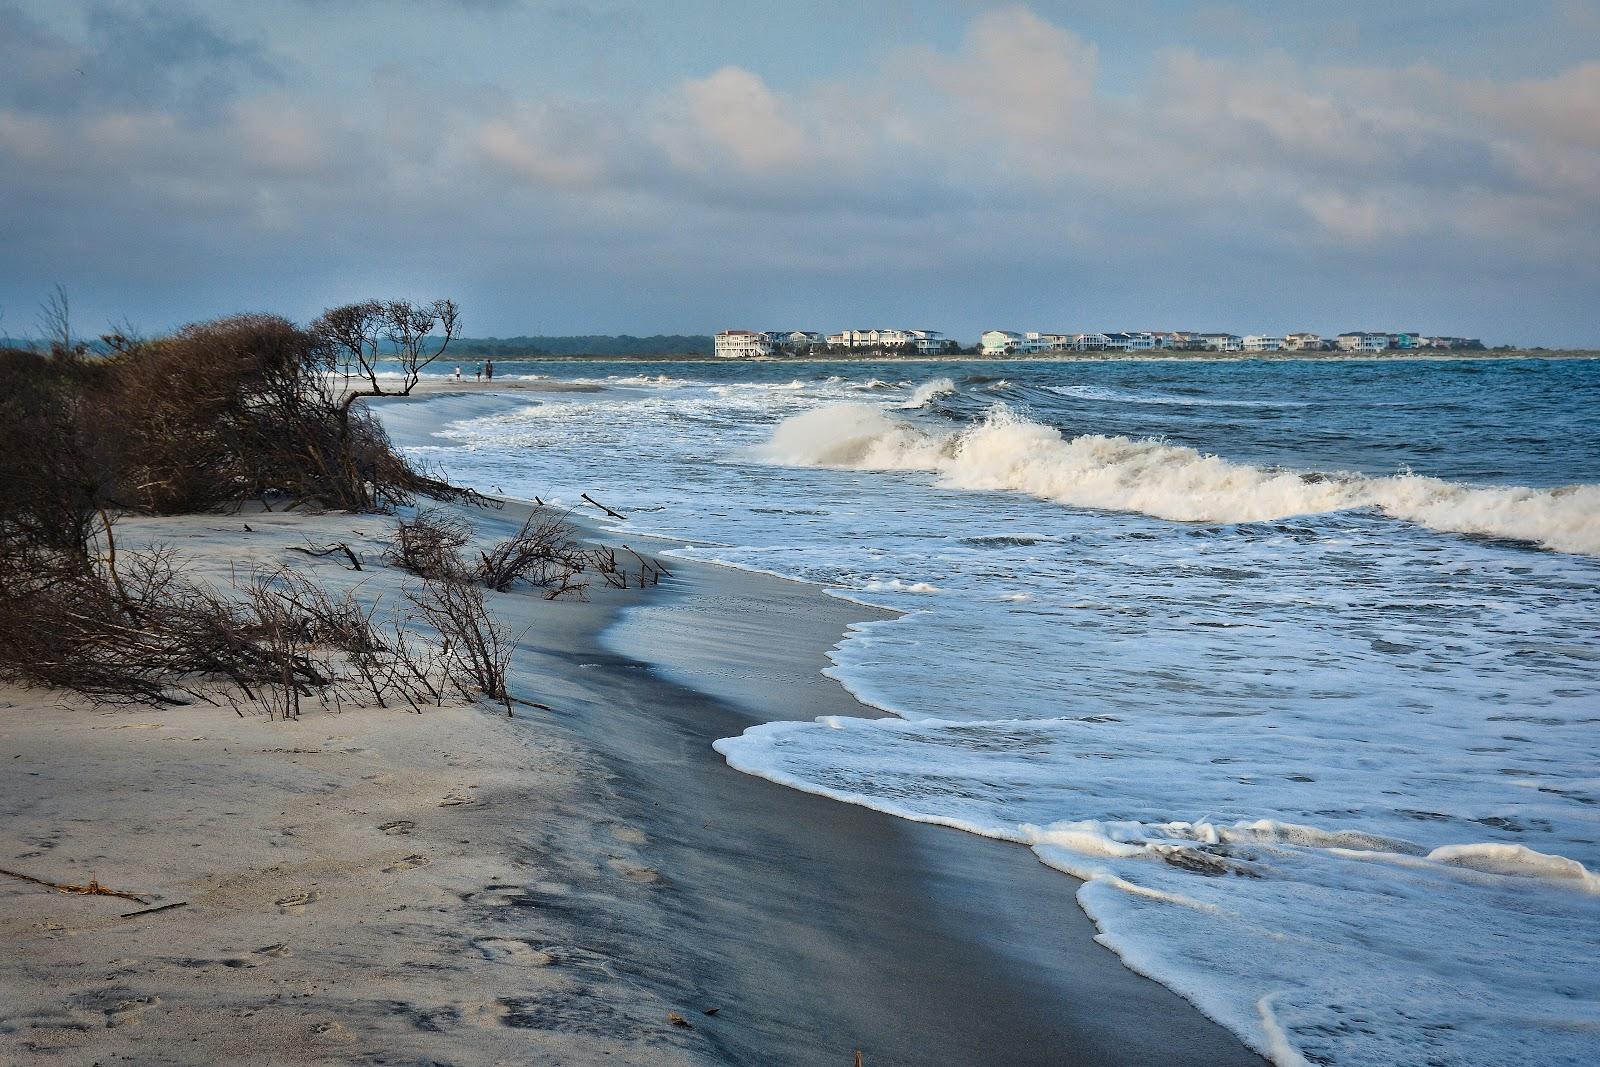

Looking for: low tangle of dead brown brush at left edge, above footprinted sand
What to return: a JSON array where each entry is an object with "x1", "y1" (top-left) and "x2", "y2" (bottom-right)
[{"x1": 0, "y1": 549, "x2": 451, "y2": 718}]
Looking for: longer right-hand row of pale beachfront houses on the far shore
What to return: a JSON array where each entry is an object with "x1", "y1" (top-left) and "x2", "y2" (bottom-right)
[{"x1": 979, "y1": 330, "x2": 1483, "y2": 357}]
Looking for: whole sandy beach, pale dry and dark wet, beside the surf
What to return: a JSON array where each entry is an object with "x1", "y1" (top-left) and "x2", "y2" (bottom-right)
[{"x1": 0, "y1": 506, "x2": 1259, "y2": 1067}]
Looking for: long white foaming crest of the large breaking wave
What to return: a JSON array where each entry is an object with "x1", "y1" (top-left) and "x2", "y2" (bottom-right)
[{"x1": 757, "y1": 403, "x2": 1600, "y2": 555}]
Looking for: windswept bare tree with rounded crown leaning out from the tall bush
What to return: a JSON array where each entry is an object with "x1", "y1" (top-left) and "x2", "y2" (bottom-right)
[{"x1": 310, "y1": 301, "x2": 461, "y2": 421}]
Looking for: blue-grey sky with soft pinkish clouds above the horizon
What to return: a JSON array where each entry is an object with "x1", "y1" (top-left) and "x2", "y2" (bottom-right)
[{"x1": 0, "y1": 0, "x2": 1600, "y2": 347}]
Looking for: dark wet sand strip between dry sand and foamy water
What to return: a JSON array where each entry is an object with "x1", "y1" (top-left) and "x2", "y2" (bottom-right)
[{"x1": 508, "y1": 550, "x2": 1262, "y2": 1067}]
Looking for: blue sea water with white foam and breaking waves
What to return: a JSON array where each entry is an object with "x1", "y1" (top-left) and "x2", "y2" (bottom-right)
[{"x1": 384, "y1": 360, "x2": 1600, "y2": 1065}]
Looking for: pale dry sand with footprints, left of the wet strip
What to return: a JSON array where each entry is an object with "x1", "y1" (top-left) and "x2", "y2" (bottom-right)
[{"x1": 0, "y1": 515, "x2": 702, "y2": 1064}]
